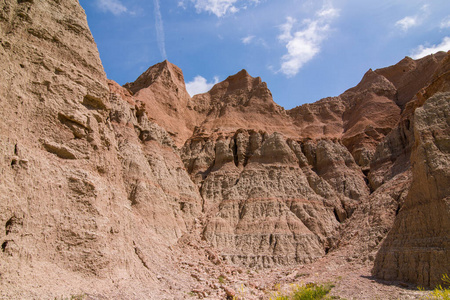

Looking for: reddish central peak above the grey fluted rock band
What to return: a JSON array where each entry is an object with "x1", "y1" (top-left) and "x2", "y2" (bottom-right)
[{"x1": 192, "y1": 70, "x2": 295, "y2": 135}]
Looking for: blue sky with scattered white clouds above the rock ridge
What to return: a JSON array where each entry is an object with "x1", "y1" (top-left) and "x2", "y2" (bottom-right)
[{"x1": 80, "y1": 0, "x2": 450, "y2": 109}]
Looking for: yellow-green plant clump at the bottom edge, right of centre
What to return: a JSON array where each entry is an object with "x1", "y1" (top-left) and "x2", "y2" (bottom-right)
[{"x1": 271, "y1": 283, "x2": 333, "y2": 300}]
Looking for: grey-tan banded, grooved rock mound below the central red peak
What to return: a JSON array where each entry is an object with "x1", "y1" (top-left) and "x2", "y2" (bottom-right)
[{"x1": 183, "y1": 130, "x2": 358, "y2": 267}]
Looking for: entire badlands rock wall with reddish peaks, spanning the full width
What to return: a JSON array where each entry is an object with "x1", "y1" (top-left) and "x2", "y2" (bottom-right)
[{"x1": 0, "y1": 0, "x2": 450, "y2": 299}]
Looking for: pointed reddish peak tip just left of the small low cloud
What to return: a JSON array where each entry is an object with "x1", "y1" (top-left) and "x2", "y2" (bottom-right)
[{"x1": 124, "y1": 60, "x2": 186, "y2": 93}]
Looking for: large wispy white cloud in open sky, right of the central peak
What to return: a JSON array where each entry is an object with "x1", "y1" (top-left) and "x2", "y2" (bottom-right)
[{"x1": 278, "y1": 6, "x2": 339, "y2": 77}]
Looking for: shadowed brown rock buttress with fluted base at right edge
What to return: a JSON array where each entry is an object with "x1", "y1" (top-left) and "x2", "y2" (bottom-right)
[{"x1": 373, "y1": 93, "x2": 450, "y2": 286}]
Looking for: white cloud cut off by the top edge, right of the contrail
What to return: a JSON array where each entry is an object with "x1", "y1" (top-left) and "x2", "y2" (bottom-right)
[{"x1": 178, "y1": 0, "x2": 260, "y2": 18}]
